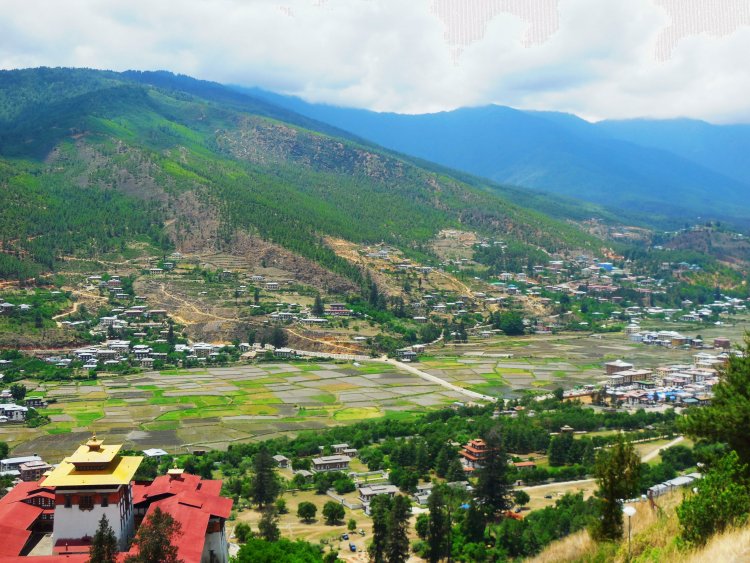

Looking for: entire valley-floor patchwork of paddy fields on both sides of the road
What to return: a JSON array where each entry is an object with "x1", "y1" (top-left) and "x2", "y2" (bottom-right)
[{"x1": 0, "y1": 317, "x2": 750, "y2": 462}]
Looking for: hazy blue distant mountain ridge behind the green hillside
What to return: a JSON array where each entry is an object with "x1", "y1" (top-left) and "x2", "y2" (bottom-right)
[{"x1": 242, "y1": 89, "x2": 750, "y2": 225}]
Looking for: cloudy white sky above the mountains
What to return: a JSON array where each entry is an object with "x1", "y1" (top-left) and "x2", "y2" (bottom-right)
[{"x1": 0, "y1": 0, "x2": 750, "y2": 123}]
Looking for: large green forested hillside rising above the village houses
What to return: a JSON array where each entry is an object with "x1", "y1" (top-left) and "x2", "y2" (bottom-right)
[{"x1": 0, "y1": 69, "x2": 599, "y2": 279}]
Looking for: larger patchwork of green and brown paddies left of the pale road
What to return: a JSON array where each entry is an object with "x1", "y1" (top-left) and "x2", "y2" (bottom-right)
[{"x1": 0, "y1": 362, "x2": 462, "y2": 462}]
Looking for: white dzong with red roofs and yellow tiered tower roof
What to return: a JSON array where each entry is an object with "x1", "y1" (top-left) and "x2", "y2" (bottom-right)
[{"x1": 0, "y1": 437, "x2": 232, "y2": 563}]
